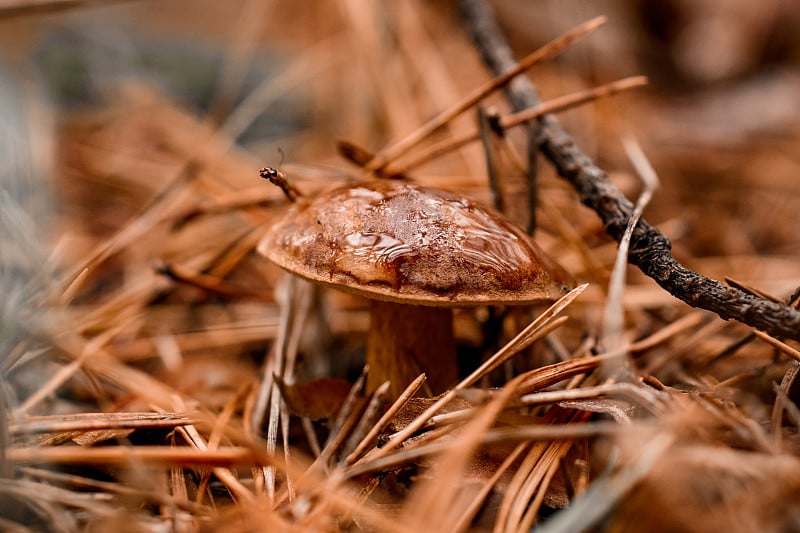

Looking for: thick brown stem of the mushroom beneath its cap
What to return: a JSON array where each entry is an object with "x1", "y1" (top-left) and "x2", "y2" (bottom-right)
[{"x1": 367, "y1": 300, "x2": 458, "y2": 398}]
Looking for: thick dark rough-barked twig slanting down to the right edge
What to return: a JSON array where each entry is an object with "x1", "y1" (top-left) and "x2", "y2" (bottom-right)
[{"x1": 461, "y1": 0, "x2": 800, "y2": 340}]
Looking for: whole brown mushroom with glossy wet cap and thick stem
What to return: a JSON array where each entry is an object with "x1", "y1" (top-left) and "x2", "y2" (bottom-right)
[{"x1": 258, "y1": 180, "x2": 572, "y2": 397}]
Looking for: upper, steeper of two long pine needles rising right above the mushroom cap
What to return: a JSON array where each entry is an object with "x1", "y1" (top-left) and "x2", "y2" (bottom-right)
[{"x1": 366, "y1": 17, "x2": 606, "y2": 171}]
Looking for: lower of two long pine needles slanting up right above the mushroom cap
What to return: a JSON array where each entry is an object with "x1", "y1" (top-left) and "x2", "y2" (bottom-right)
[{"x1": 386, "y1": 76, "x2": 647, "y2": 175}]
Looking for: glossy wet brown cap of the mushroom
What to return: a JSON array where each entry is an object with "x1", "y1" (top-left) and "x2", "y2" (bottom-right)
[{"x1": 258, "y1": 180, "x2": 572, "y2": 307}]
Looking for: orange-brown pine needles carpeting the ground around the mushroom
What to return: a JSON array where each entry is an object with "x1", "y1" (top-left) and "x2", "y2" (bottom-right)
[{"x1": 0, "y1": 1, "x2": 800, "y2": 532}]
